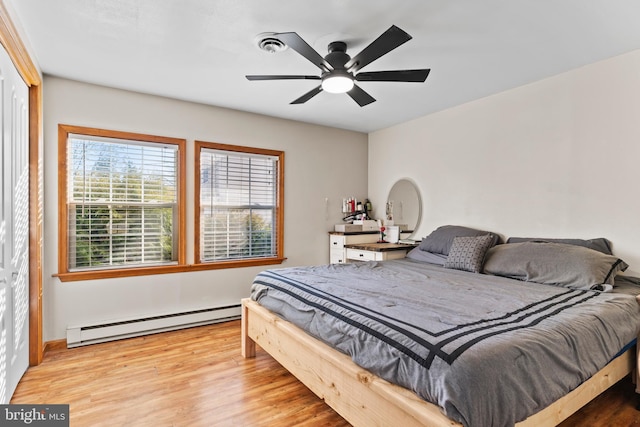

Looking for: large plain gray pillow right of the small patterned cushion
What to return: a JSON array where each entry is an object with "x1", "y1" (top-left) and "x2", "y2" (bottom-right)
[{"x1": 484, "y1": 242, "x2": 628, "y2": 289}]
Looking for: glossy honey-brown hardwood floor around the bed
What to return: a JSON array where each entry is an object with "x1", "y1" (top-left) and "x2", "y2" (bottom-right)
[{"x1": 11, "y1": 321, "x2": 640, "y2": 427}]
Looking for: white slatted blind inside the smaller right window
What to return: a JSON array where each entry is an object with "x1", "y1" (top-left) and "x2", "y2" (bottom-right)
[{"x1": 200, "y1": 148, "x2": 278, "y2": 262}]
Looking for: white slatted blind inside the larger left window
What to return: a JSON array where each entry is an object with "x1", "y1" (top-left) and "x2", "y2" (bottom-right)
[{"x1": 67, "y1": 135, "x2": 178, "y2": 270}]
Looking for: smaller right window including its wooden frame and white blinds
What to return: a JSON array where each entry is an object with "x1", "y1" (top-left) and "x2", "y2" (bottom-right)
[{"x1": 195, "y1": 141, "x2": 284, "y2": 267}]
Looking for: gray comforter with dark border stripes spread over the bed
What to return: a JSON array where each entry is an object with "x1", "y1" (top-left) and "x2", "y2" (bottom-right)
[{"x1": 251, "y1": 259, "x2": 640, "y2": 427}]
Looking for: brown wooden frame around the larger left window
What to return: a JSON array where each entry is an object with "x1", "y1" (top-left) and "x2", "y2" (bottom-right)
[{"x1": 55, "y1": 124, "x2": 186, "y2": 282}]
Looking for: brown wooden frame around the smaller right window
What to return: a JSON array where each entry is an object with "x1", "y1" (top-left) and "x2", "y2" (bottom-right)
[{"x1": 194, "y1": 141, "x2": 286, "y2": 269}]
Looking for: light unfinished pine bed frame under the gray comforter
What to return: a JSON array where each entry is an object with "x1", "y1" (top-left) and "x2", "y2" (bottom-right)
[{"x1": 242, "y1": 298, "x2": 637, "y2": 427}]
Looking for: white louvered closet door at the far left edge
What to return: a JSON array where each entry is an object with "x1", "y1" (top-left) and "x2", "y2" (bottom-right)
[{"x1": 0, "y1": 41, "x2": 29, "y2": 404}]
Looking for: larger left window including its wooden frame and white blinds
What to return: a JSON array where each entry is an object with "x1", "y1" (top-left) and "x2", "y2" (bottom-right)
[{"x1": 58, "y1": 125, "x2": 185, "y2": 280}]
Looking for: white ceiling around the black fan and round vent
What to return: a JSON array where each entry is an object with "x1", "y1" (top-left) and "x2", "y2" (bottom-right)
[{"x1": 4, "y1": 0, "x2": 640, "y2": 132}]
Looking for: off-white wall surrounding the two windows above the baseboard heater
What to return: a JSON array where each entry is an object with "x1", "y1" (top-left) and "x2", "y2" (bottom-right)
[{"x1": 43, "y1": 76, "x2": 367, "y2": 342}]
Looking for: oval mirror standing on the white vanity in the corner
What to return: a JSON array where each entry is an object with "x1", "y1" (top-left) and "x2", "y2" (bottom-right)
[{"x1": 386, "y1": 179, "x2": 422, "y2": 238}]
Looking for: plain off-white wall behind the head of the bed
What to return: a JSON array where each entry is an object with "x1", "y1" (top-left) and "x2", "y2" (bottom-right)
[{"x1": 369, "y1": 51, "x2": 640, "y2": 275}]
